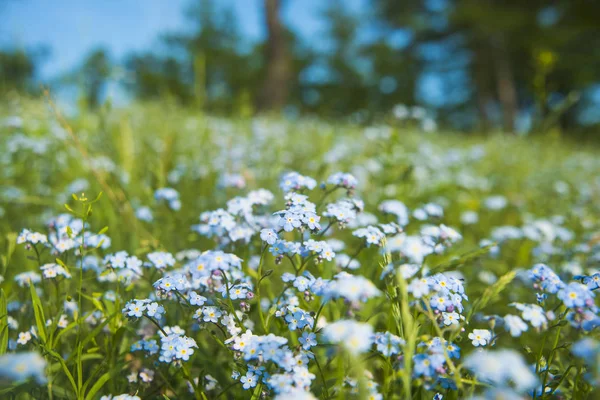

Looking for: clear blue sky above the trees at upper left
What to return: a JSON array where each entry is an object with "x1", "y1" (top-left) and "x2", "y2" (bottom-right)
[{"x1": 0, "y1": 0, "x2": 364, "y2": 77}]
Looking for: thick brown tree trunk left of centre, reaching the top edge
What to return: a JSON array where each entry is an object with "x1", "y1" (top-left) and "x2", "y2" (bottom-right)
[{"x1": 258, "y1": 0, "x2": 291, "y2": 111}]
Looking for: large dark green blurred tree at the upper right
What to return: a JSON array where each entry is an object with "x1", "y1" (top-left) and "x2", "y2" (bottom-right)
[{"x1": 377, "y1": 0, "x2": 600, "y2": 132}]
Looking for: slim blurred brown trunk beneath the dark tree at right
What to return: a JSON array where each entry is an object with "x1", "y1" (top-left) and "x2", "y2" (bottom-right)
[{"x1": 493, "y1": 36, "x2": 518, "y2": 133}]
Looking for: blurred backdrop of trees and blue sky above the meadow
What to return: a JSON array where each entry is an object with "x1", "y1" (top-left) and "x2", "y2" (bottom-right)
[{"x1": 0, "y1": 0, "x2": 600, "y2": 137}]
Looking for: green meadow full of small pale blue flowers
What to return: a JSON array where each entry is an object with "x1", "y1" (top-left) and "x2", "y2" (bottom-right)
[{"x1": 0, "y1": 99, "x2": 600, "y2": 400}]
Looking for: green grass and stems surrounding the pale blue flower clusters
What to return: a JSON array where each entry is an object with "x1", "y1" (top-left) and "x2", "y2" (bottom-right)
[{"x1": 0, "y1": 99, "x2": 600, "y2": 399}]
